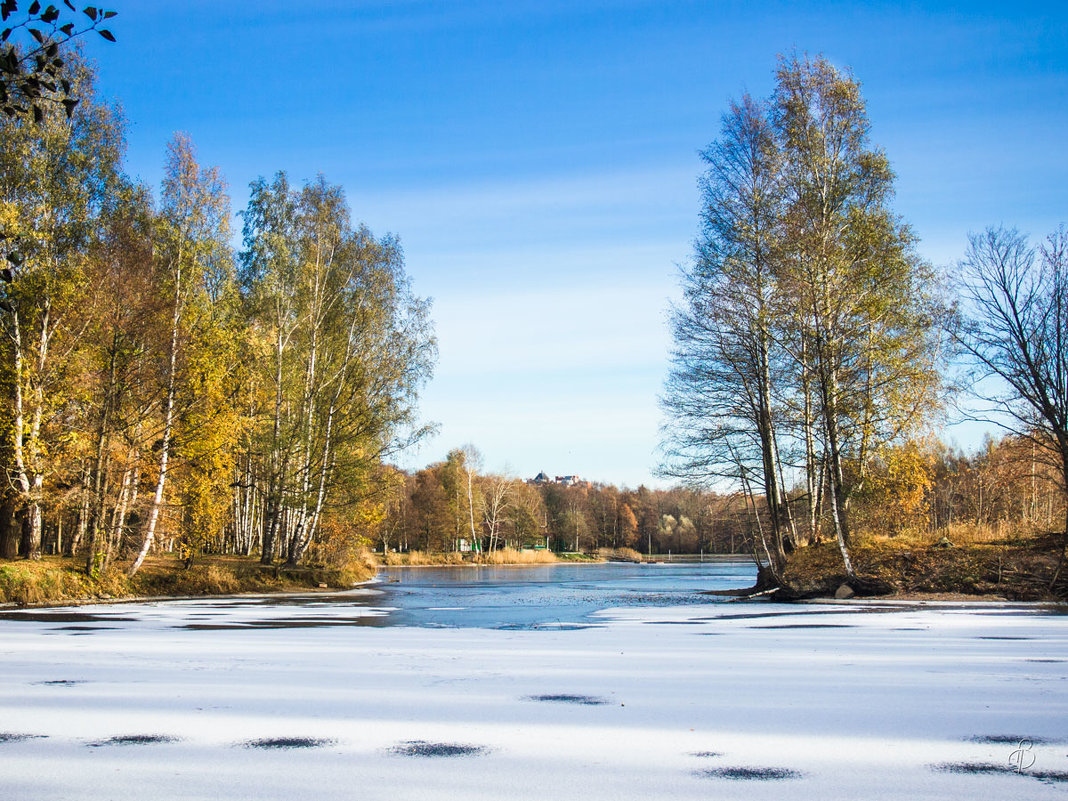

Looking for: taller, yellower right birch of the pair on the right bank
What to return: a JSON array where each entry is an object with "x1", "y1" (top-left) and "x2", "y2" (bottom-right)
[{"x1": 774, "y1": 51, "x2": 940, "y2": 575}]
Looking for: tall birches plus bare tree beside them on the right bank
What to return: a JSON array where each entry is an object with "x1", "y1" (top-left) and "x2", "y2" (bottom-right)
[{"x1": 661, "y1": 56, "x2": 1068, "y2": 583}]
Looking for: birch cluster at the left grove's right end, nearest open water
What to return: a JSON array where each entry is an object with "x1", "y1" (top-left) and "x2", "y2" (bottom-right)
[{"x1": 240, "y1": 173, "x2": 435, "y2": 564}]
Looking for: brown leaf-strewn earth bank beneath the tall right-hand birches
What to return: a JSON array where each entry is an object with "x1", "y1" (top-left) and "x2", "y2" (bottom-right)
[{"x1": 785, "y1": 533, "x2": 1068, "y2": 601}]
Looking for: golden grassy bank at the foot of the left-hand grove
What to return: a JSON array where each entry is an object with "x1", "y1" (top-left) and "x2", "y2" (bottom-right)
[{"x1": 0, "y1": 555, "x2": 376, "y2": 606}]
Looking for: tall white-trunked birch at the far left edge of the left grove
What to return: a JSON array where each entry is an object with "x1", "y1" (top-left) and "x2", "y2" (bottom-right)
[{"x1": 0, "y1": 59, "x2": 124, "y2": 557}]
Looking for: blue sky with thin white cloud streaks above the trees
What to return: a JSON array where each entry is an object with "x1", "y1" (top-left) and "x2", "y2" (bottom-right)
[{"x1": 90, "y1": 0, "x2": 1068, "y2": 486}]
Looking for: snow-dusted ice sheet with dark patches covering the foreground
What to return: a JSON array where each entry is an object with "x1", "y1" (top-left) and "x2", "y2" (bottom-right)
[{"x1": 0, "y1": 591, "x2": 1068, "y2": 801}]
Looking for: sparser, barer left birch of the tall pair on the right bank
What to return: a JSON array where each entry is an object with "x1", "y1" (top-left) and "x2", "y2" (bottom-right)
[{"x1": 662, "y1": 95, "x2": 786, "y2": 576}]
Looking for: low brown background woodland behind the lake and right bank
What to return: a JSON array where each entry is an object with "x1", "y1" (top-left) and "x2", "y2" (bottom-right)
[{"x1": 367, "y1": 436, "x2": 1064, "y2": 559}]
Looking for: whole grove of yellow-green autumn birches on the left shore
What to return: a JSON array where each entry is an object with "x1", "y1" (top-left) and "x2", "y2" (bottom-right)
[{"x1": 0, "y1": 53, "x2": 436, "y2": 575}]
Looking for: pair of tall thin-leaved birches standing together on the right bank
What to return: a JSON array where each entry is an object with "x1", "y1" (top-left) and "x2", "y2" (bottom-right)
[{"x1": 664, "y1": 57, "x2": 941, "y2": 582}]
